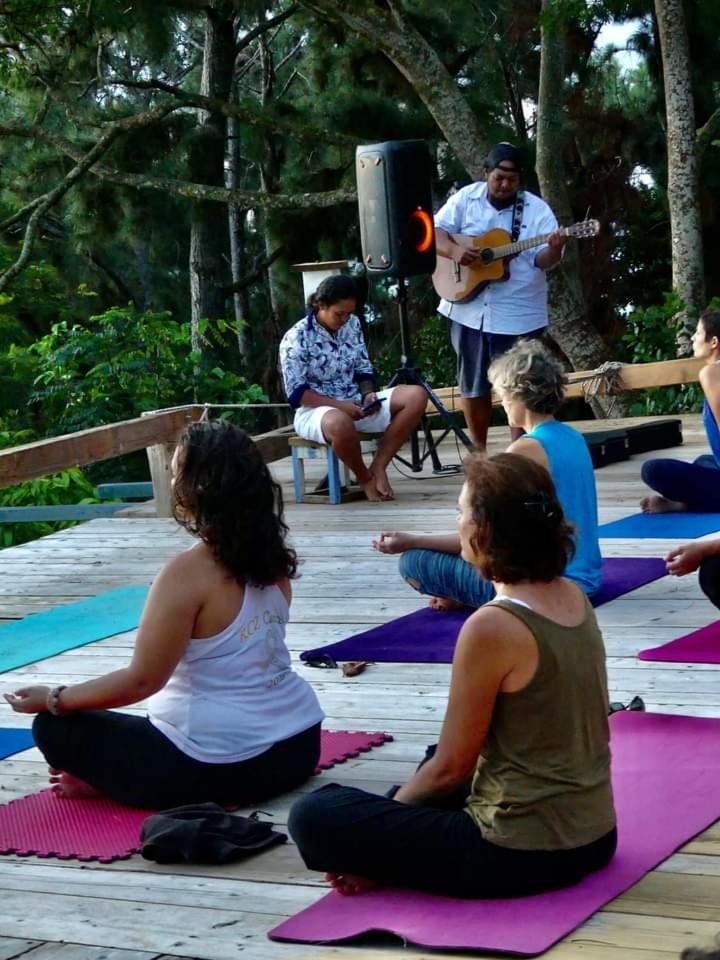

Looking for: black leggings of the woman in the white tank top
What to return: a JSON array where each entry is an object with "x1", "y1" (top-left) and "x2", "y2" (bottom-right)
[{"x1": 33, "y1": 710, "x2": 320, "y2": 810}]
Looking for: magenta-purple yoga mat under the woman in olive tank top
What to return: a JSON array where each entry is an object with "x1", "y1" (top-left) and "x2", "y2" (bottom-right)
[{"x1": 269, "y1": 712, "x2": 720, "y2": 956}]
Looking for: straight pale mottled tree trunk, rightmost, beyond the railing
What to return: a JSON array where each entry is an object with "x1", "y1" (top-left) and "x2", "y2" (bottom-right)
[{"x1": 655, "y1": 0, "x2": 705, "y2": 334}]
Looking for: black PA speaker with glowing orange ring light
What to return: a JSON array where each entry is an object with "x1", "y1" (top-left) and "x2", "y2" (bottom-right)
[{"x1": 355, "y1": 140, "x2": 435, "y2": 277}]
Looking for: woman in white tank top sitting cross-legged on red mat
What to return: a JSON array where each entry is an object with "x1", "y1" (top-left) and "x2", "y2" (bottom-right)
[{"x1": 5, "y1": 421, "x2": 323, "y2": 809}]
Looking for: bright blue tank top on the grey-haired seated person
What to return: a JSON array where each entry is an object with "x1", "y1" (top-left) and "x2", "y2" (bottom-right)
[{"x1": 528, "y1": 420, "x2": 602, "y2": 594}]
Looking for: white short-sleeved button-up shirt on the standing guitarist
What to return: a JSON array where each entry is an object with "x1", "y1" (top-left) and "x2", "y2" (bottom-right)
[{"x1": 435, "y1": 182, "x2": 558, "y2": 336}]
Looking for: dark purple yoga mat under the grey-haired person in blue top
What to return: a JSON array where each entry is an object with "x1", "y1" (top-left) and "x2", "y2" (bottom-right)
[{"x1": 300, "y1": 557, "x2": 667, "y2": 663}]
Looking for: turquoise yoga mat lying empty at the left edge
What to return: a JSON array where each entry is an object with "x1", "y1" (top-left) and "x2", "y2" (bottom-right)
[{"x1": 0, "y1": 587, "x2": 148, "y2": 673}]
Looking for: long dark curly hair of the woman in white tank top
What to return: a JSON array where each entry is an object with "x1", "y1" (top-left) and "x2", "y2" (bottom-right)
[{"x1": 173, "y1": 420, "x2": 297, "y2": 587}]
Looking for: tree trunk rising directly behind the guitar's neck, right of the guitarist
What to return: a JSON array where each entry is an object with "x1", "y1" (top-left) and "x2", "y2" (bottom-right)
[{"x1": 536, "y1": 0, "x2": 617, "y2": 415}]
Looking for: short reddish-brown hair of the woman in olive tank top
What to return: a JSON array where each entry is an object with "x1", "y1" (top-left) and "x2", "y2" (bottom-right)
[{"x1": 465, "y1": 453, "x2": 575, "y2": 583}]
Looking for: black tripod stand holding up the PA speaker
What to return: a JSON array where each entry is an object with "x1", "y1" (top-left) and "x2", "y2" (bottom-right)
[{"x1": 388, "y1": 277, "x2": 475, "y2": 473}]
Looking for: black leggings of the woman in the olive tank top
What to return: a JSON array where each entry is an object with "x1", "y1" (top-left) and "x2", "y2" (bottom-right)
[{"x1": 288, "y1": 783, "x2": 617, "y2": 897}]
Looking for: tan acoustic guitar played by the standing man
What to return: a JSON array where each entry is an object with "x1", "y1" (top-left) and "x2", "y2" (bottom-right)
[{"x1": 432, "y1": 220, "x2": 600, "y2": 303}]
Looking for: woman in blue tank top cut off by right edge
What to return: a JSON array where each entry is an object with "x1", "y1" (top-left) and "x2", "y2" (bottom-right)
[{"x1": 640, "y1": 310, "x2": 720, "y2": 513}]
